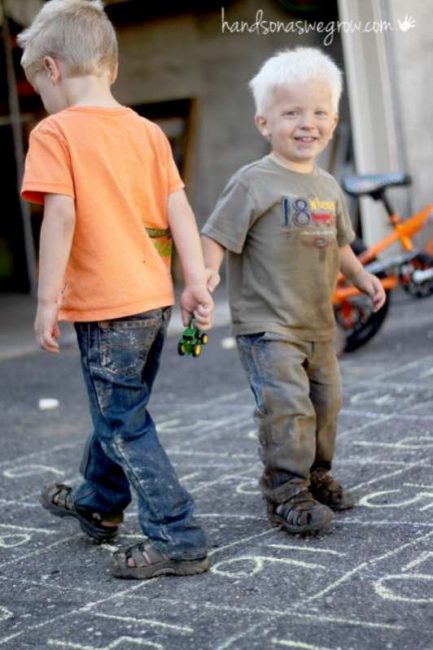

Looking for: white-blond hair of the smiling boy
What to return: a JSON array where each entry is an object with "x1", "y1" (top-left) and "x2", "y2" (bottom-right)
[{"x1": 249, "y1": 47, "x2": 343, "y2": 115}]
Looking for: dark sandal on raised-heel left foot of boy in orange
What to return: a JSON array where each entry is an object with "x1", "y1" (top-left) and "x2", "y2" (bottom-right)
[{"x1": 41, "y1": 483, "x2": 122, "y2": 544}]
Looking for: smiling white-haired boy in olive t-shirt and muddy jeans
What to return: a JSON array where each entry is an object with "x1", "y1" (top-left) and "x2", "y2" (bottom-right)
[{"x1": 202, "y1": 48, "x2": 385, "y2": 533}]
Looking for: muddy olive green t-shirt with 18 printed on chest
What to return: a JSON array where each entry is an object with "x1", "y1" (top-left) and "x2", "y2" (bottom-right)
[{"x1": 202, "y1": 156, "x2": 355, "y2": 341}]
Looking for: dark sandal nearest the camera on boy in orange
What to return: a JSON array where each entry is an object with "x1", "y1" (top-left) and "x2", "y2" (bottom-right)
[{"x1": 111, "y1": 540, "x2": 209, "y2": 580}]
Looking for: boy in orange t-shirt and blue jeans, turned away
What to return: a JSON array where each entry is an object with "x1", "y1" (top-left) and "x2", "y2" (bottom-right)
[{"x1": 19, "y1": 0, "x2": 213, "y2": 578}]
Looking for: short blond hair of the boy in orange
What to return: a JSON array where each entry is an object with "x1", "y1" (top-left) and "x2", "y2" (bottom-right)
[{"x1": 17, "y1": 0, "x2": 118, "y2": 79}]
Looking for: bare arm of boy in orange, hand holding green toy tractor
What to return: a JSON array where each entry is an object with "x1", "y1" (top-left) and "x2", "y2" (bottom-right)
[{"x1": 167, "y1": 190, "x2": 213, "y2": 329}]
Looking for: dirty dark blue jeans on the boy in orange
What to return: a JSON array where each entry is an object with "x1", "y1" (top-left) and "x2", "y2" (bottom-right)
[{"x1": 74, "y1": 308, "x2": 207, "y2": 559}]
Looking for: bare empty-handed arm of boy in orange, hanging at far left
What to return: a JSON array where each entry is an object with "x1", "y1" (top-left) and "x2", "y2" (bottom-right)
[{"x1": 35, "y1": 194, "x2": 75, "y2": 352}]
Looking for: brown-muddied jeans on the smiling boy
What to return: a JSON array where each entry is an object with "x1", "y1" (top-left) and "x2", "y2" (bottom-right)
[{"x1": 236, "y1": 332, "x2": 341, "y2": 503}]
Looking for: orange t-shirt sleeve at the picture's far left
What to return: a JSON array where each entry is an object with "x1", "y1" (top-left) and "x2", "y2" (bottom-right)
[{"x1": 21, "y1": 120, "x2": 75, "y2": 203}]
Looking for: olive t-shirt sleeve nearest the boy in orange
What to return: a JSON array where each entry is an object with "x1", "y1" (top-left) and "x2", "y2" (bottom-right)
[{"x1": 202, "y1": 175, "x2": 255, "y2": 254}]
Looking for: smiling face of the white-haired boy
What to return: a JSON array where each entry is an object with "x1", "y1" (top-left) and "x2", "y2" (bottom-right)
[{"x1": 256, "y1": 79, "x2": 338, "y2": 173}]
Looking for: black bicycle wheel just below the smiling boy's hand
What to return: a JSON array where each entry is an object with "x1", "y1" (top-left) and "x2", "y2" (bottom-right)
[{"x1": 334, "y1": 291, "x2": 391, "y2": 352}]
